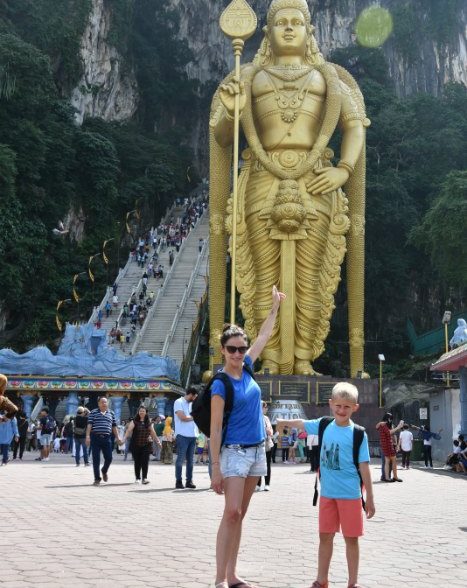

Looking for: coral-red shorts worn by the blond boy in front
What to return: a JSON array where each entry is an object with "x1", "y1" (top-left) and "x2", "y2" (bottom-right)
[{"x1": 319, "y1": 496, "x2": 363, "y2": 537}]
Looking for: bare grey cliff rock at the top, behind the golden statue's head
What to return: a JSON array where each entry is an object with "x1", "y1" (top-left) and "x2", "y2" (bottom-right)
[{"x1": 166, "y1": 0, "x2": 467, "y2": 96}]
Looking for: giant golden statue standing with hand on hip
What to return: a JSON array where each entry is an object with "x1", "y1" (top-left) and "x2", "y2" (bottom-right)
[{"x1": 209, "y1": 0, "x2": 369, "y2": 376}]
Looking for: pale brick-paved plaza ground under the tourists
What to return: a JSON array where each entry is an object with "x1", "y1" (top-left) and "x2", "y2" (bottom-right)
[{"x1": 0, "y1": 455, "x2": 467, "y2": 588}]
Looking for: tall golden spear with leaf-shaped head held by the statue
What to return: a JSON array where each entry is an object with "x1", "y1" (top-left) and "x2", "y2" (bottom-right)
[{"x1": 219, "y1": 0, "x2": 257, "y2": 324}]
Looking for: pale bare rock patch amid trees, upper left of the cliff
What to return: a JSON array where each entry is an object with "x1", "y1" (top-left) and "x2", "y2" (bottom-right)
[{"x1": 71, "y1": 0, "x2": 138, "y2": 124}]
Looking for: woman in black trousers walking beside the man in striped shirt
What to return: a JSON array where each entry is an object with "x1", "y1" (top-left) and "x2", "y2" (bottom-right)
[{"x1": 123, "y1": 405, "x2": 161, "y2": 484}]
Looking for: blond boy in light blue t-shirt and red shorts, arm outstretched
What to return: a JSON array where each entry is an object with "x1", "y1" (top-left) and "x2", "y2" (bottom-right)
[{"x1": 277, "y1": 382, "x2": 375, "y2": 588}]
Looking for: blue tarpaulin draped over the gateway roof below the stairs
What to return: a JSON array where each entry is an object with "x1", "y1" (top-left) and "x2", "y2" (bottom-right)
[{"x1": 0, "y1": 324, "x2": 180, "y2": 381}]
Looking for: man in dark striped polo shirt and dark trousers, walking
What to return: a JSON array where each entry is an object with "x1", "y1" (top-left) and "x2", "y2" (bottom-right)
[{"x1": 86, "y1": 396, "x2": 121, "y2": 486}]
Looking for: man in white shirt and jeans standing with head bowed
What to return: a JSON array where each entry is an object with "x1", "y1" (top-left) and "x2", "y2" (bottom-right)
[{"x1": 174, "y1": 387, "x2": 198, "y2": 490}]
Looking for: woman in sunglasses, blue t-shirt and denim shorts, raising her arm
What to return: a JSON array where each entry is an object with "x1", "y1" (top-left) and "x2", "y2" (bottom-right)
[{"x1": 210, "y1": 286, "x2": 285, "y2": 588}]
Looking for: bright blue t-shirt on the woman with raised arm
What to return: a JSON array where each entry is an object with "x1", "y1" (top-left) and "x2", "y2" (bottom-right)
[{"x1": 211, "y1": 355, "x2": 266, "y2": 445}]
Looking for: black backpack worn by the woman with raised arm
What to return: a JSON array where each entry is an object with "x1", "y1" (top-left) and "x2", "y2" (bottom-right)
[{"x1": 191, "y1": 364, "x2": 255, "y2": 442}]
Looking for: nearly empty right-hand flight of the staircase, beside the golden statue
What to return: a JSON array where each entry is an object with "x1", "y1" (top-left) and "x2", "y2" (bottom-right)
[{"x1": 132, "y1": 211, "x2": 209, "y2": 358}]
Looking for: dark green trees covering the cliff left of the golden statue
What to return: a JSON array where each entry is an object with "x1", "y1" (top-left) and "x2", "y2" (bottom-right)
[{"x1": 0, "y1": 0, "x2": 194, "y2": 349}]
